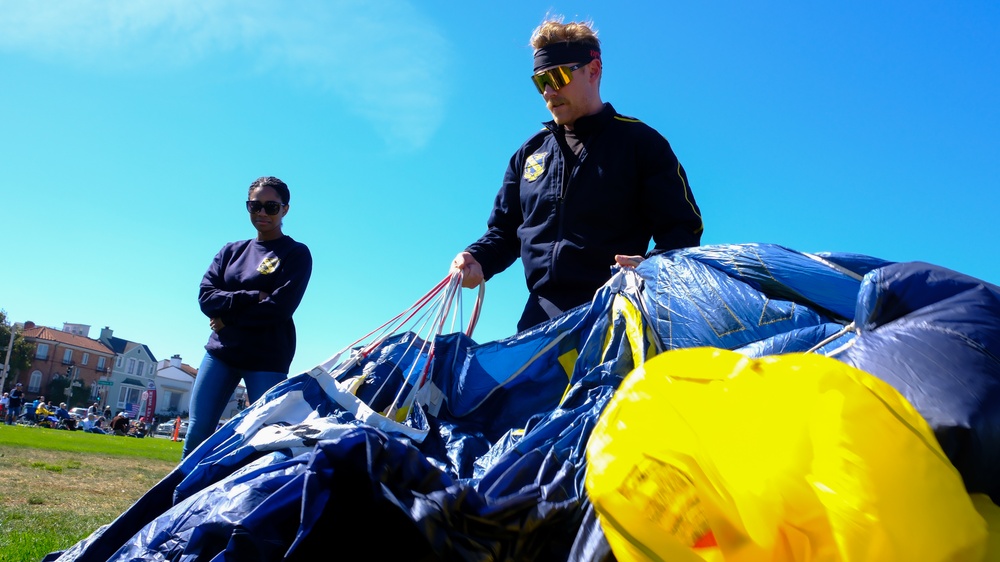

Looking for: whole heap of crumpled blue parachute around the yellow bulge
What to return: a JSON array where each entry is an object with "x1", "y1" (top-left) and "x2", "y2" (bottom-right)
[{"x1": 46, "y1": 244, "x2": 1000, "y2": 561}]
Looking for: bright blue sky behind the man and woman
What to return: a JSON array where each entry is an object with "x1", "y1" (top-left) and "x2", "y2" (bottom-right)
[{"x1": 0, "y1": 0, "x2": 1000, "y2": 373}]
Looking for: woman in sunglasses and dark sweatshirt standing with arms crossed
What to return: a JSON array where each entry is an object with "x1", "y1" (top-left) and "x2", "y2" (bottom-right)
[{"x1": 181, "y1": 176, "x2": 312, "y2": 457}]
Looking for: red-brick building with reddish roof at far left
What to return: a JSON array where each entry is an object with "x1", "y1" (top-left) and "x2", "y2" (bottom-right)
[{"x1": 18, "y1": 322, "x2": 115, "y2": 407}]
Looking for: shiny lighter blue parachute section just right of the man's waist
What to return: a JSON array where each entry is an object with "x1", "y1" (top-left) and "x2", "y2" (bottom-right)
[{"x1": 636, "y1": 245, "x2": 862, "y2": 350}]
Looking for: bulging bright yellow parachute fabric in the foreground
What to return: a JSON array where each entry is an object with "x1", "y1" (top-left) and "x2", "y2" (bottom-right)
[{"x1": 586, "y1": 348, "x2": 995, "y2": 562}]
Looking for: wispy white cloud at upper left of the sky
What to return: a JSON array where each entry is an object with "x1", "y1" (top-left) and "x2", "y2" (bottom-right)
[{"x1": 0, "y1": 0, "x2": 451, "y2": 149}]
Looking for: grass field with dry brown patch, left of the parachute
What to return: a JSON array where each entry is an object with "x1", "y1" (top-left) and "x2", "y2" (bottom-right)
[{"x1": 0, "y1": 424, "x2": 182, "y2": 562}]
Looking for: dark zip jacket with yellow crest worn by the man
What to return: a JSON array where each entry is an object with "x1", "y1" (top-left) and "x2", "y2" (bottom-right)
[{"x1": 467, "y1": 104, "x2": 703, "y2": 318}]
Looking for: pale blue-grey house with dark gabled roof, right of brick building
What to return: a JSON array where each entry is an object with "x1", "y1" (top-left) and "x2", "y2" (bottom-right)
[{"x1": 99, "y1": 326, "x2": 156, "y2": 415}]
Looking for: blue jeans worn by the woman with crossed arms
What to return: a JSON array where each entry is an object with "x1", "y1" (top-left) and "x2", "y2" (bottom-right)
[{"x1": 181, "y1": 353, "x2": 288, "y2": 458}]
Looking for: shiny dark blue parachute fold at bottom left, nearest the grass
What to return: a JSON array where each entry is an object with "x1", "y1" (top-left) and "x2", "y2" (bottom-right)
[{"x1": 66, "y1": 427, "x2": 451, "y2": 562}]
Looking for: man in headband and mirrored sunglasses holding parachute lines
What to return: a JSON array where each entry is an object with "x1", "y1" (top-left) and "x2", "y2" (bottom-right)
[{"x1": 452, "y1": 20, "x2": 704, "y2": 331}]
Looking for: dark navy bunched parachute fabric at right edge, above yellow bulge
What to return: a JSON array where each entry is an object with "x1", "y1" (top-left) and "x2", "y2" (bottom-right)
[{"x1": 836, "y1": 263, "x2": 1000, "y2": 503}]
